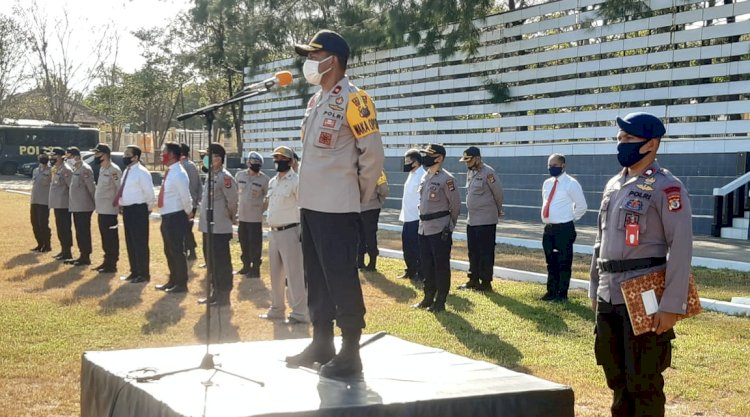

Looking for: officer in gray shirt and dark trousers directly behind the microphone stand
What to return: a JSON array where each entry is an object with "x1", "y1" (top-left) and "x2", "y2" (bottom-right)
[{"x1": 198, "y1": 143, "x2": 239, "y2": 306}]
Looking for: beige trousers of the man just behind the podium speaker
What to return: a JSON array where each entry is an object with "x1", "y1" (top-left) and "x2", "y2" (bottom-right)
[{"x1": 268, "y1": 226, "x2": 310, "y2": 321}]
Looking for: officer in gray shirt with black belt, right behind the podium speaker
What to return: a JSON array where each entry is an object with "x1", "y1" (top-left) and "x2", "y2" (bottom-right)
[{"x1": 413, "y1": 144, "x2": 461, "y2": 313}]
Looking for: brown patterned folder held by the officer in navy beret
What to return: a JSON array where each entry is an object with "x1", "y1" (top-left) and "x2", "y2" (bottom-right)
[{"x1": 620, "y1": 271, "x2": 703, "y2": 336}]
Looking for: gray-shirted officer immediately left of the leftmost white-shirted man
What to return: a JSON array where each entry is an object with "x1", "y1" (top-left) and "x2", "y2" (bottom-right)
[{"x1": 92, "y1": 143, "x2": 122, "y2": 273}]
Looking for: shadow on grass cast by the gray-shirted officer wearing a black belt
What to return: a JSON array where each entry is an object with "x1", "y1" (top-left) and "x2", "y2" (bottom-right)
[{"x1": 435, "y1": 310, "x2": 527, "y2": 372}]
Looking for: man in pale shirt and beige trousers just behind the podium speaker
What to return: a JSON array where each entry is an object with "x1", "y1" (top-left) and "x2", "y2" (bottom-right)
[{"x1": 260, "y1": 146, "x2": 310, "y2": 324}]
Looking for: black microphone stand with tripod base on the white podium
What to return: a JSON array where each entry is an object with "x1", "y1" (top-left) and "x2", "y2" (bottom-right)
[{"x1": 135, "y1": 85, "x2": 272, "y2": 387}]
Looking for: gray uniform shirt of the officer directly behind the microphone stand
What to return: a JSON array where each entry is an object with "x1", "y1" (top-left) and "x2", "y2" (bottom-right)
[{"x1": 198, "y1": 168, "x2": 239, "y2": 234}]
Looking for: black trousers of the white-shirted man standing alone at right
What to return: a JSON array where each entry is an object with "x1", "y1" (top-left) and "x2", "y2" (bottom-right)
[{"x1": 542, "y1": 222, "x2": 577, "y2": 298}]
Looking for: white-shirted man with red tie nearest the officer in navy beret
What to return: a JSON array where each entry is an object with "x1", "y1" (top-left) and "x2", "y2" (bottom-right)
[{"x1": 542, "y1": 154, "x2": 587, "y2": 301}]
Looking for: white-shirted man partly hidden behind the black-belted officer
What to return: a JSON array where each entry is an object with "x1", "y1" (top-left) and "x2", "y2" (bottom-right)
[{"x1": 398, "y1": 149, "x2": 426, "y2": 282}]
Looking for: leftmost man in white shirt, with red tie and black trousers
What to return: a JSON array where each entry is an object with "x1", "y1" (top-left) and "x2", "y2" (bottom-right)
[{"x1": 117, "y1": 145, "x2": 156, "y2": 284}]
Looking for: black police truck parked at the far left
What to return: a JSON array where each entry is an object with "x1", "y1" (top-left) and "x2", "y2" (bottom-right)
[{"x1": 0, "y1": 123, "x2": 99, "y2": 175}]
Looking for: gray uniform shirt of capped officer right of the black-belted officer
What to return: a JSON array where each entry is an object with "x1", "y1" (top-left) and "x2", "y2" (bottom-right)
[{"x1": 466, "y1": 163, "x2": 503, "y2": 226}]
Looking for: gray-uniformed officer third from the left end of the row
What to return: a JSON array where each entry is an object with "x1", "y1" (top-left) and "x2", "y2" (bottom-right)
[{"x1": 65, "y1": 146, "x2": 96, "y2": 266}]
